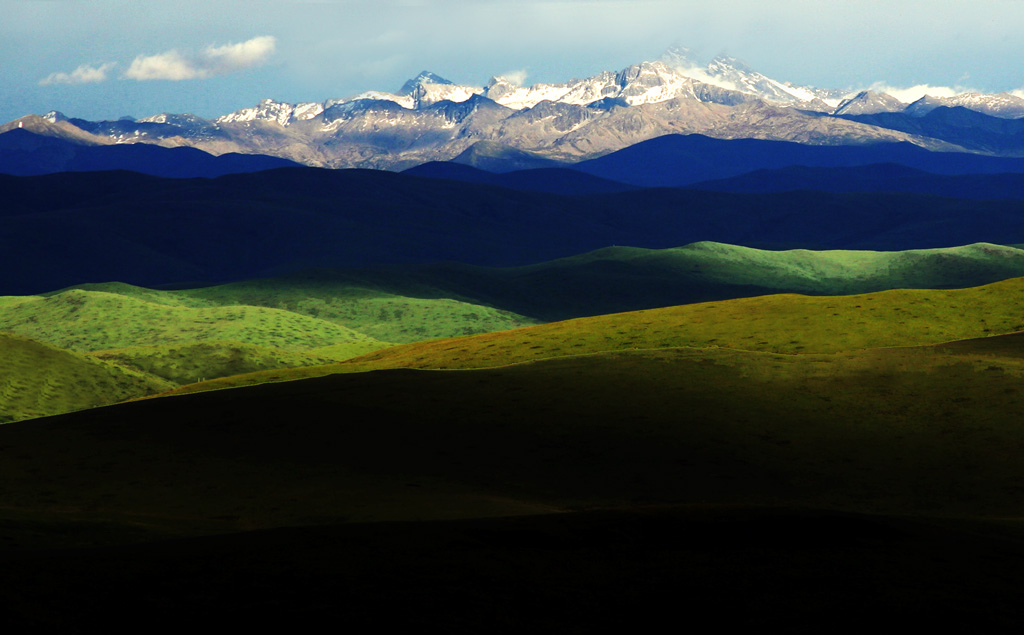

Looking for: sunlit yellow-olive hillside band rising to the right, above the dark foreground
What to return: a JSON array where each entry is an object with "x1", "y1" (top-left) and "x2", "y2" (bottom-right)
[{"x1": 167, "y1": 279, "x2": 1024, "y2": 391}]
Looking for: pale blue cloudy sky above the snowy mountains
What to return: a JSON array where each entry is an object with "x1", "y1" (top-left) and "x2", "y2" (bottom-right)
[{"x1": 0, "y1": 0, "x2": 1024, "y2": 122}]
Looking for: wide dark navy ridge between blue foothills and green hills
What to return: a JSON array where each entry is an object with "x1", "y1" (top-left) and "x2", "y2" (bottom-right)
[{"x1": 6, "y1": 168, "x2": 1024, "y2": 295}]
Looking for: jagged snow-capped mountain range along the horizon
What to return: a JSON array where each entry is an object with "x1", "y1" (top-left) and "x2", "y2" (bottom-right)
[{"x1": 12, "y1": 48, "x2": 1024, "y2": 168}]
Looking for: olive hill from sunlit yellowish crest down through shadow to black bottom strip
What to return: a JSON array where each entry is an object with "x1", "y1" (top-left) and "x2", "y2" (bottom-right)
[{"x1": 0, "y1": 279, "x2": 1024, "y2": 531}]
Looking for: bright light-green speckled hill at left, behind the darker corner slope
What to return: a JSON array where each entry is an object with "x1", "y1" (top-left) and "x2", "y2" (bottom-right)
[{"x1": 0, "y1": 285, "x2": 389, "y2": 401}]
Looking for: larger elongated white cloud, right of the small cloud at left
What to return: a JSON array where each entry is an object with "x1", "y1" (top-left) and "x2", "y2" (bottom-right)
[{"x1": 122, "y1": 35, "x2": 278, "y2": 81}]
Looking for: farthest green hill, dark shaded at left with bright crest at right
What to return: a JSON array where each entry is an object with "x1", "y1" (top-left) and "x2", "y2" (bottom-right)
[{"x1": 307, "y1": 242, "x2": 1024, "y2": 319}]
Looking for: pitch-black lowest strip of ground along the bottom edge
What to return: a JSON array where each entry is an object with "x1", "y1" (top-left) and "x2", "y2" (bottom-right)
[{"x1": 0, "y1": 506, "x2": 1024, "y2": 633}]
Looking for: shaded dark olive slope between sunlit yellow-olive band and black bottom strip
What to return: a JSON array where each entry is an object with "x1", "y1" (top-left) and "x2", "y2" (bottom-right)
[{"x1": 6, "y1": 336, "x2": 1024, "y2": 533}]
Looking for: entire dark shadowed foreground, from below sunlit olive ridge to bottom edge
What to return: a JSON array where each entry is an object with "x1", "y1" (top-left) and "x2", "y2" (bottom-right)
[{"x1": 0, "y1": 337, "x2": 1024, "y2": 631}]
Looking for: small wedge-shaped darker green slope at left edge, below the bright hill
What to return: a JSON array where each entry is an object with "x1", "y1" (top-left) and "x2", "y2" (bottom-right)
[{"x1": 0, "y1": 333, "x2": 174, "y2": 423}]
